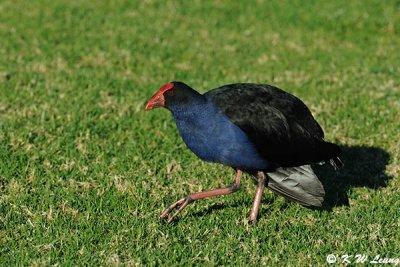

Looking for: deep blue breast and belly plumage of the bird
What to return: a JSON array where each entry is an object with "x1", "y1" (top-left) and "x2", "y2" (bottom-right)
[{"x1": 171, "y1": 101, "x2": 270, "y2": 170}]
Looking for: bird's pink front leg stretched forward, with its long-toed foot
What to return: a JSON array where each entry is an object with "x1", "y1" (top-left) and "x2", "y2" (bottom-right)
[{"x1": 160, "y1": 170, "x2": 242, "y2": 223}]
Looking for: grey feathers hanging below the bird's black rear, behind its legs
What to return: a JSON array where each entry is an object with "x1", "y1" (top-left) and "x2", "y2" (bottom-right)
[{"x1": 268, "y1": 165, "x2": 325, "y2": 207}]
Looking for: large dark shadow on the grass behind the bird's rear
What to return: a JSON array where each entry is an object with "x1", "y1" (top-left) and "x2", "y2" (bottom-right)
[{"x1": 312, "y1": 145, "x2": 392, "y2": 210}]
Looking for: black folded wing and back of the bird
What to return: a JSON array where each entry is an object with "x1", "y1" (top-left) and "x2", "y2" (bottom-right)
[{"x1": 204, "y1": 83, "x2": 340, "y2": 167}]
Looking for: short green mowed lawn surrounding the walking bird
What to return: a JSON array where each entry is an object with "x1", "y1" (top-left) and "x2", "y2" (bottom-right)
[{"x1": 0, "y1": 1, "x2": 400, "y2": 266}]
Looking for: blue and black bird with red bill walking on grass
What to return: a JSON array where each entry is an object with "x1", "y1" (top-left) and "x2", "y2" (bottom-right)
[{"x1": 145, "y1": 81, "x2": 343, "y2": 224}]
